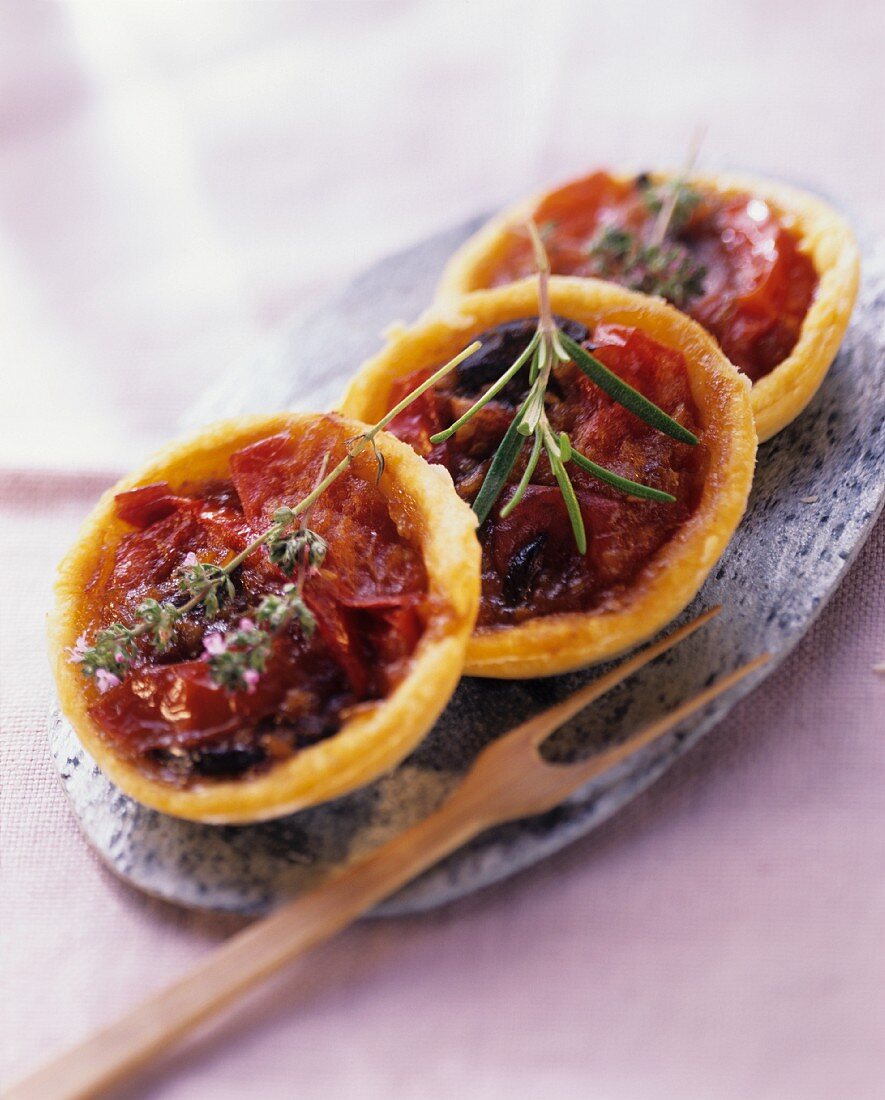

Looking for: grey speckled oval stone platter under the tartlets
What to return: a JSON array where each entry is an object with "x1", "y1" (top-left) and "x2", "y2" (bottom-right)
[{"x1": 49, "y1": 223, "x2": 885, "y2": 914}]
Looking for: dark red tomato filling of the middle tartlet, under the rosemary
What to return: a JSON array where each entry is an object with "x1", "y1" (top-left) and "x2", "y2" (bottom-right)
[{"x1": 388, "y1": 319, "x2": 708, "y2": 628}]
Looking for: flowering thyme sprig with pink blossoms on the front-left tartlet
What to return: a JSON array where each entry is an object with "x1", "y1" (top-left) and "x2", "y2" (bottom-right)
[{"x1": 68, "y1": 341, "x2": 480, "y2": 692}]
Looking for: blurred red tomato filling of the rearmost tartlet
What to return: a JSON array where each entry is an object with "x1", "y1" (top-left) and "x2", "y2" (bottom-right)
[{"x1": 479, "y1": 172, "x2": 818, "y2": 382}]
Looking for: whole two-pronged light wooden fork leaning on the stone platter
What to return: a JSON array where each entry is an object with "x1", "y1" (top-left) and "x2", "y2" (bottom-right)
[{"x1": 7, "y1": 607, "x2": 768, "y2": 1100}]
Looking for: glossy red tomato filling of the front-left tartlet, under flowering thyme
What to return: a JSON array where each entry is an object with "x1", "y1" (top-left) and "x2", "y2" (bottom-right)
[{"x1": 82, "y1": 421, "x2": 428, "y2": 783}]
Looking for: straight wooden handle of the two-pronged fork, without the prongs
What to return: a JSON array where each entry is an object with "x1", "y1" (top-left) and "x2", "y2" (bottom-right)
[{"x1": 5, "y1": 791, "x2": 490, "y2": 1100}]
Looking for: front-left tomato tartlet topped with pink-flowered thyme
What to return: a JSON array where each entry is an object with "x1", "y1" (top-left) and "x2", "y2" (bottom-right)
[{"x1": 49, "y1": 414, "x2": 479, "y2": 823}]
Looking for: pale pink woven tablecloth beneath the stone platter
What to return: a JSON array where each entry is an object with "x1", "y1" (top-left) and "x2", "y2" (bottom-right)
[{"x1": 0, "y1": 0, "x2": 885, "y2": 1100}]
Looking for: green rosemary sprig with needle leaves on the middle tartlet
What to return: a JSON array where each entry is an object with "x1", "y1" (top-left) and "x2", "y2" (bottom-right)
[{"x1": 430, "y1": 221, "x2": 698, "y2": 553}]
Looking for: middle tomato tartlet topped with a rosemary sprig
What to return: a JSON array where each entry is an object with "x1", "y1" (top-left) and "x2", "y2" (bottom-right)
[{"x1": 342, "y1": 276, "x2": 756, "y2": 678}]
